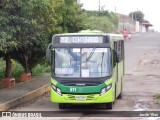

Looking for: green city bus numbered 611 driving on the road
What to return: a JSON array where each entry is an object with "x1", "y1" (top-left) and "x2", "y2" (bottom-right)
[{"x1": 47, "y1": 31, "x2": 125, "y2": 109}]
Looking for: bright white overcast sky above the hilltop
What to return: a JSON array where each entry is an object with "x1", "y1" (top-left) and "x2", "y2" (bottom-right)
[{"x1": 80, "y1": 0, "x2": 160, "y2": 31}]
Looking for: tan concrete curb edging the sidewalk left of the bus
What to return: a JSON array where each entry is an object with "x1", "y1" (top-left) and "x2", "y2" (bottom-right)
[{"x1": 0, "y1": 84, "x2": 50, "y2": 111}]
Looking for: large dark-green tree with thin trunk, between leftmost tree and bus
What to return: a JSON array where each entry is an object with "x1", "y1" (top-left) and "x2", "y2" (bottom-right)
[{"x1": 10, "y1": 0, "x2": 55, "y2": 73}]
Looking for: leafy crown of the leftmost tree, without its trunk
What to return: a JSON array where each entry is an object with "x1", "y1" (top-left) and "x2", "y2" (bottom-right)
[{"x1": 0, "y1": 0, "x2": 18, "y2": 53}]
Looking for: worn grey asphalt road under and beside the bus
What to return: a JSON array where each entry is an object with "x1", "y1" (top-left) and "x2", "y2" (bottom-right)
[{"x1": 8, "y1": 33, "x2": 160, "y2": 120}]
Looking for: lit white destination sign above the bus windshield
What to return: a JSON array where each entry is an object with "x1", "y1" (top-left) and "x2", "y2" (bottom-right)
[{"x1": 60, "y1": 36, "x2": 103, "y2": 43}]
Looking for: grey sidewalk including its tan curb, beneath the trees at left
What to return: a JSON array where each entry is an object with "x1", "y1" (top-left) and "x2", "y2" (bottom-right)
[{"x1": 0, "y1": 74, "x2": 50, "y2": 111}]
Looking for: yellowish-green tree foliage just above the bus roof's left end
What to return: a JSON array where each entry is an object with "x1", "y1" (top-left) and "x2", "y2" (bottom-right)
[{"x1": 55, "y1": 0, "x2": 85, "y2": 33}]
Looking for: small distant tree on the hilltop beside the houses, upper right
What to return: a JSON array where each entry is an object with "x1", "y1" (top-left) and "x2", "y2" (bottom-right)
[{"x1": 129, "y1": 11, "x2": 144, "y2": 22}]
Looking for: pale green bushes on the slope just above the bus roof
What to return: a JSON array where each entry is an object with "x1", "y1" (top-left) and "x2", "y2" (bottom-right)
[{"x1": 85, "y1": 11, "x2": 118, "y2": 33}]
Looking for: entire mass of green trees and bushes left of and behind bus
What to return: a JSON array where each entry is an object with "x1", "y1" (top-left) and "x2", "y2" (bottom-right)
[{"x1": 0, "y1": 0, "x2": 118, "y2": 83}]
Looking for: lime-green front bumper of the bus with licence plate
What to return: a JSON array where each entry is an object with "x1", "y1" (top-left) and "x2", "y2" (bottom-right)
[{"x1": 51, "y1": 89, "x2": 114, "y2": 104}]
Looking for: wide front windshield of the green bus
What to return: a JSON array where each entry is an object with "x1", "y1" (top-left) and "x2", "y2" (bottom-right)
[{"x1": 52, "y1": 48, "x2": 111, "y2": 78}]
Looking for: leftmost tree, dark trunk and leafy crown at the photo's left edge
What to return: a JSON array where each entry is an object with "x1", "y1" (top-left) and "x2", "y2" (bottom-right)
[{"x1": 0, "y1": 1, "x2": 18, "y2": 78}]
